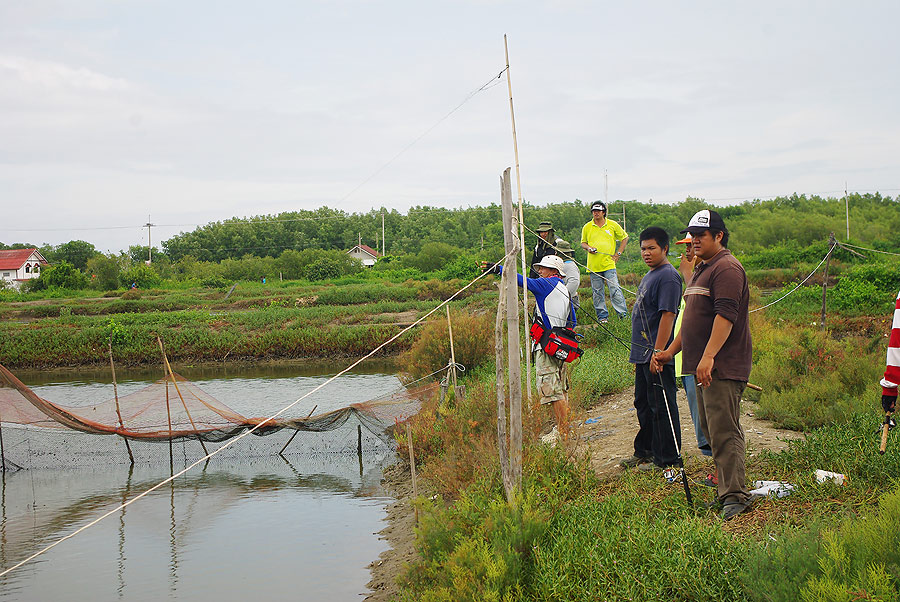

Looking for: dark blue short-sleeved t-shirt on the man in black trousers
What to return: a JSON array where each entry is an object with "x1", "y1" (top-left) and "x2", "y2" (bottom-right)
[{"x1": 628, "y1": 262, "x2": 681, "y2": 364}]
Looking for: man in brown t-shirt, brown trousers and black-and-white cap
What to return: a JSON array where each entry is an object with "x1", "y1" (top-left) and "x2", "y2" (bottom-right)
[{"x1": 654, "y1": 209, "x2": 752, "y2": 520}]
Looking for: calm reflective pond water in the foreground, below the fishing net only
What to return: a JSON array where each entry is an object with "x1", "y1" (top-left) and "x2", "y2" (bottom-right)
[{"x1": 0, "y1": 455, "x2": 394, "y2": 600}]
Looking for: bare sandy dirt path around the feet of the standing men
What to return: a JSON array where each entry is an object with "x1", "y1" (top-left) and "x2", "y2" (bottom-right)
[{"x1": 576, "y1": 389, "x2": 802, "y2": 477}]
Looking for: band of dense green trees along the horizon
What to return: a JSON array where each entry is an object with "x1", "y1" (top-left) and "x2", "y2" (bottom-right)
[{"x1": 0, "y1": 193, "x2": 900, "y2": 289}]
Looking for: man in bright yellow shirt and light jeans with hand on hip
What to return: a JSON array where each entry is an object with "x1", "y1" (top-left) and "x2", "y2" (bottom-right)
[{"x1": 581, "y1": 201, "x2": 628, "y2": 324}]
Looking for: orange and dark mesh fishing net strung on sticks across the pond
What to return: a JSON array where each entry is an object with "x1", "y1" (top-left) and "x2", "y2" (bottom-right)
[{"x1": 0, "y1": 365, "x2": 438, "y2": 468}]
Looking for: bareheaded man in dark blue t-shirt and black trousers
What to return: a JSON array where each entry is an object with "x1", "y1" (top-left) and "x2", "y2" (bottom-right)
[{"x1": 621, "y1": 226, "x2": 681, "y2": 470}]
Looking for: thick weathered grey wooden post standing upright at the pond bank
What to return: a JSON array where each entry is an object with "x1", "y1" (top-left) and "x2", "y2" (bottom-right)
[{"x1": 500, "y1": 168, "x2": 527, "y2": 502}]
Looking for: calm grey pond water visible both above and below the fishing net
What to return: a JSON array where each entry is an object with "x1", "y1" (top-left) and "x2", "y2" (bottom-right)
[{"x1": 0, "y1": 364, "x2": 400, "y2": 601}]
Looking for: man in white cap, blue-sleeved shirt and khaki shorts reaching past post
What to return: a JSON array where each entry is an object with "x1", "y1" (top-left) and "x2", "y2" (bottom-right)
[{"x1": 481, "y1": 255, "x2": 575, "y2": 437}]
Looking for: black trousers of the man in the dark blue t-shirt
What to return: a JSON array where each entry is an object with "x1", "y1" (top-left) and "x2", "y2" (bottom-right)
[{"x1": 634, "y1": 363, "x2": 681, "y2": 466}]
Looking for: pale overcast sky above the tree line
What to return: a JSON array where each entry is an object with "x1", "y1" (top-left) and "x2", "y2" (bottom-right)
[{"x1": 0, "y1": 0, "x2": 900, "y2": 252}]
